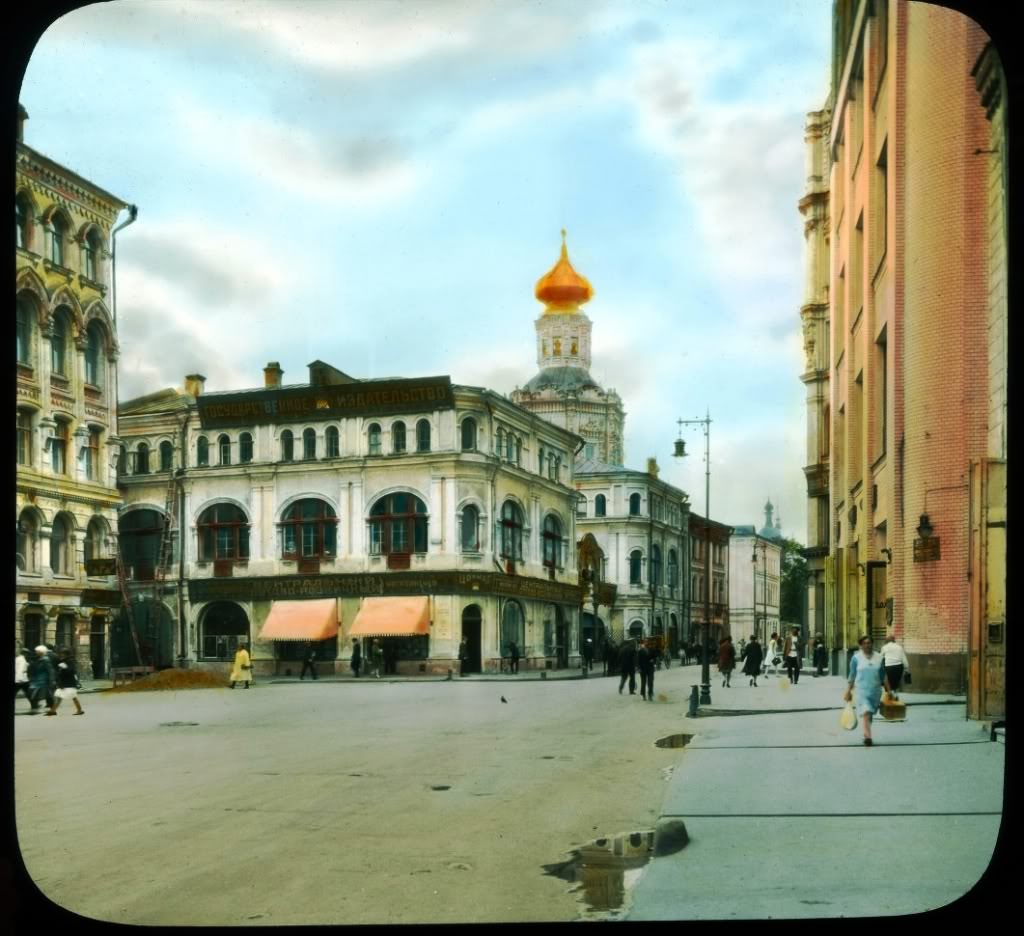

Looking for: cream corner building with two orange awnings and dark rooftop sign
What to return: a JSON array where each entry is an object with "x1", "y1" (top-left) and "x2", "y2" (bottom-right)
[{"x1": 115, "y1": 360, "x2": 583, "y2": 677}]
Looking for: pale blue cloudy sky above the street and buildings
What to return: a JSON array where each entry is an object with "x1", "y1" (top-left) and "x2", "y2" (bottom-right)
[{"x1": 19, "y1": 0, "x2": 831, "y2": 542}]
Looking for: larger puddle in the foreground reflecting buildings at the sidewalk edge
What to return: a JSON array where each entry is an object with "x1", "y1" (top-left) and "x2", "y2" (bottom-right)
[{"x1": 544, "y1": 829, "x2": 654, "y2": 919}]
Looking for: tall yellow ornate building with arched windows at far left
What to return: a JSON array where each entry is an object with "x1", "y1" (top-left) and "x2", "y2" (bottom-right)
[{"x1": 14, "y1": 100, "x2": 136, "y2": 676}]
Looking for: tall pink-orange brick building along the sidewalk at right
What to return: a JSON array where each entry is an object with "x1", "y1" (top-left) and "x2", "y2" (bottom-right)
[{"x1": 799, "y1": 0, "x2": 1009, "y2": 717}]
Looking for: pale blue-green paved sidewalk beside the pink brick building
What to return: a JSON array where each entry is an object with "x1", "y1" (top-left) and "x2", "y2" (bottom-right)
[{"x1": 626, "y1": 672, "x2": 1006, "y2": 921}]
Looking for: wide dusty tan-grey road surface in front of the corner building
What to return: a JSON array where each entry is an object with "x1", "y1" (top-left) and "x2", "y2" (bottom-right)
[{"x1": 14, "y1": 667, "x2": 696, "y2": 925}]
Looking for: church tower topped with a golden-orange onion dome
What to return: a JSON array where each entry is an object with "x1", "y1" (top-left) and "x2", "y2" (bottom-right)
[{"x1": 511, "y1": 230, "x2": 626, "y2": 465}]
